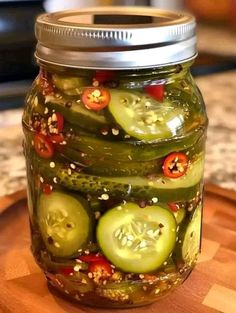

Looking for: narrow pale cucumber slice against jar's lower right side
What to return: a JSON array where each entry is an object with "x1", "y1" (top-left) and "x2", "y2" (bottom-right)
[{"x1": 182, "y1": 205, "x2": 202, "y2": 266}]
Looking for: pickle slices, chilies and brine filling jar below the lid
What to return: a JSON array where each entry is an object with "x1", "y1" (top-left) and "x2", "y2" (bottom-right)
[{"x1": 23, "y1": 66, "x2": 207, "y2": 307}]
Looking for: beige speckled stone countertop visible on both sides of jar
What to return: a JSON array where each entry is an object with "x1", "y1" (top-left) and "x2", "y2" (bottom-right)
[{"x1": 0, "y1": 71, "x2": 236, "y2": 196}]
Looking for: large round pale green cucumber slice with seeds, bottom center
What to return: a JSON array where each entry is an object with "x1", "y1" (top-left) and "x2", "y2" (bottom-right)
[{"x1": 97, "y1": 202, "x2": 176, "y2": 273}]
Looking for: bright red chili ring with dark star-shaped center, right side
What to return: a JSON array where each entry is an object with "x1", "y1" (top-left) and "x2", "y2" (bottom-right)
[{"x1": 162, "y1": 152, "x2": 188, "y2": 178}]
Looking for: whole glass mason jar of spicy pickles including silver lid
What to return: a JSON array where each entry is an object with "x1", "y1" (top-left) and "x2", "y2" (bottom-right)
[{"x1": 23, "y1": 7, "x2": 207, "y2": 307}]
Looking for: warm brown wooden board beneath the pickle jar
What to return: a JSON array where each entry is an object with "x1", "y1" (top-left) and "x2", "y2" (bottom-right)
[{"x1": 0, "y1": 185, "x2": 236, "y2": 313}]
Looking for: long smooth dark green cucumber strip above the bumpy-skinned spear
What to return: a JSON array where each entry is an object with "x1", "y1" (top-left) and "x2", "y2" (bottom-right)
[{"x1": 67, "y1": 128, "x2": 205, "y2": 162}]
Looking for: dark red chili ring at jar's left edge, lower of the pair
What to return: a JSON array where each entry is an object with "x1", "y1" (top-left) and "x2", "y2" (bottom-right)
[{"x1": 34, "y1": 134, "x2": 54, "y2": 159}]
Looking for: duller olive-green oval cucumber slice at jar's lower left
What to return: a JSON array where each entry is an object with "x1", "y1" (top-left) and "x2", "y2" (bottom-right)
[{"x1": 38, "y1": 191, "x2": 91, "y2": 257}]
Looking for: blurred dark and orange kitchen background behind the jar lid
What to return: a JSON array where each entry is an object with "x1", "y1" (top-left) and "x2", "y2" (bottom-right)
[{"x1": 0, "y1": 0, "x2": 236, "y2": 110}]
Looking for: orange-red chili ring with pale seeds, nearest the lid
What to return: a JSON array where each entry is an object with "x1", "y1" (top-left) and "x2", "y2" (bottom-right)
[{"x1": 81, "y1": 87, "x2": 111, "y2": 111}]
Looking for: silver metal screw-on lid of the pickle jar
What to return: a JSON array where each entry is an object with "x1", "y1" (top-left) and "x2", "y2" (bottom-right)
[{"x1": 35, "y1": 7, "x2": 197, "y2": 69}]
